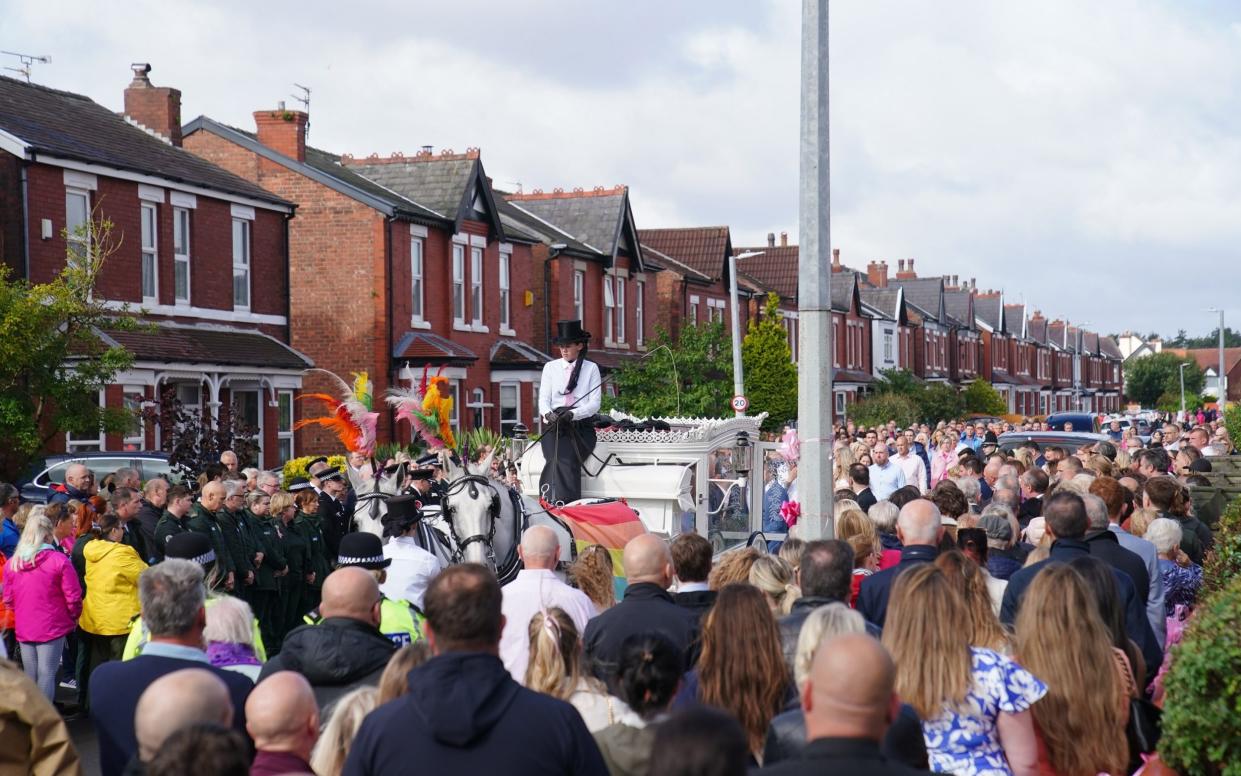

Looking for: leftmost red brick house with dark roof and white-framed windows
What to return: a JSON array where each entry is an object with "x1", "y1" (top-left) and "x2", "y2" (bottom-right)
[{"x1": 0, "y1": 66, "x2": 311, "y2": 467}]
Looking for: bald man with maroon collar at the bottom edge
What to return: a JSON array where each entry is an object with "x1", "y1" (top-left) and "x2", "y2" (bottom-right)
[{"x1": 246, "y1": 670, "x2": 319, "y2": 776}]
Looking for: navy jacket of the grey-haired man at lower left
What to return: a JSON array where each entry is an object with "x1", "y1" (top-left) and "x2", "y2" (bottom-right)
[{"x1": 91, "y1": 654, "x2": 254, "y2": 776}]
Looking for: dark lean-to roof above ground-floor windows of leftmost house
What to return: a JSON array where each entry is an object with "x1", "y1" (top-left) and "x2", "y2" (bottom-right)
[{"x1": 93, "y1": 324, "x2": 314, "y2": 370}]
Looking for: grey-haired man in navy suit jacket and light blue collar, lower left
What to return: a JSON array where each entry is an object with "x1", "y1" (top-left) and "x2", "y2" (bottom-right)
[{"x1": 89, "y1": 557, "x2": 253, "y2": 776}]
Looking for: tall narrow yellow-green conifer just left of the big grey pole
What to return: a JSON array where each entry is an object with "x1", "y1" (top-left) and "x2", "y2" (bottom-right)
[{"x1": 741, "y1": 293, "x2": 797, "y2": 431}]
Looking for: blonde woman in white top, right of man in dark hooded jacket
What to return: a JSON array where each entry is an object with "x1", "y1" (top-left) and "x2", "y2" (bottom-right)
[{"x1": 522, "y1": 606, "x2": 642, "y2": 734}]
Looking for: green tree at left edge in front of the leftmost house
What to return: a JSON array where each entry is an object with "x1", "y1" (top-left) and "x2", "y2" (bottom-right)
[{"x1": 0, "y1": 214, "x2": 140, "y2": 479}]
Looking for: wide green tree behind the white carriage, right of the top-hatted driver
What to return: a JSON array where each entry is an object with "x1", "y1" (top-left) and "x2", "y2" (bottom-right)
[{"x1": 603, "y1": 323, "x2": 732, "y2": 417}]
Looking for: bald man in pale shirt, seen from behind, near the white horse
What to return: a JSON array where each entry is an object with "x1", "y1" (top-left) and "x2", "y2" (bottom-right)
[{"x1": 500, "y1": 525, "x2": 598, "y2": 683}]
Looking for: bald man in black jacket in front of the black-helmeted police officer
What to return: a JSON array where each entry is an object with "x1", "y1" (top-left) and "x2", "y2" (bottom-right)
[{"x1": 258, "y1": 566, "x2": 396, "y2": 709}]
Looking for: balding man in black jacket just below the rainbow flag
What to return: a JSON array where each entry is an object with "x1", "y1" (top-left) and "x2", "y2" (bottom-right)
[{"x1": 582, "y1": 534, "x2": 697, "y2": 688}]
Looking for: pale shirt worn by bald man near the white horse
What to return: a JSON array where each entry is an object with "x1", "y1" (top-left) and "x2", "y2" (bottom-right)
[{"x1": 500, "y1": 566, "x2": 598, "y2": 683}]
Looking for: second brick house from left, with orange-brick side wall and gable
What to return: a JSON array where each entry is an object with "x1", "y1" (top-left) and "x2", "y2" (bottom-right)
[{"x1": 185, "y1": 112, "x2": 545, "y2": 452}]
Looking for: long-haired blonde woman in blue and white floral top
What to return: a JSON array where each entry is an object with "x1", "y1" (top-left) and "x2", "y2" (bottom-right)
[{"x1": 882, "y1": 564, "x2": 1047, "y2": 776}]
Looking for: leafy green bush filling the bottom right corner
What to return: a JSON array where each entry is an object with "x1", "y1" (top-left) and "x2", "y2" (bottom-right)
[{"x1": 1159, "y1": 579, "x2": 1241, "y2": 776}]
